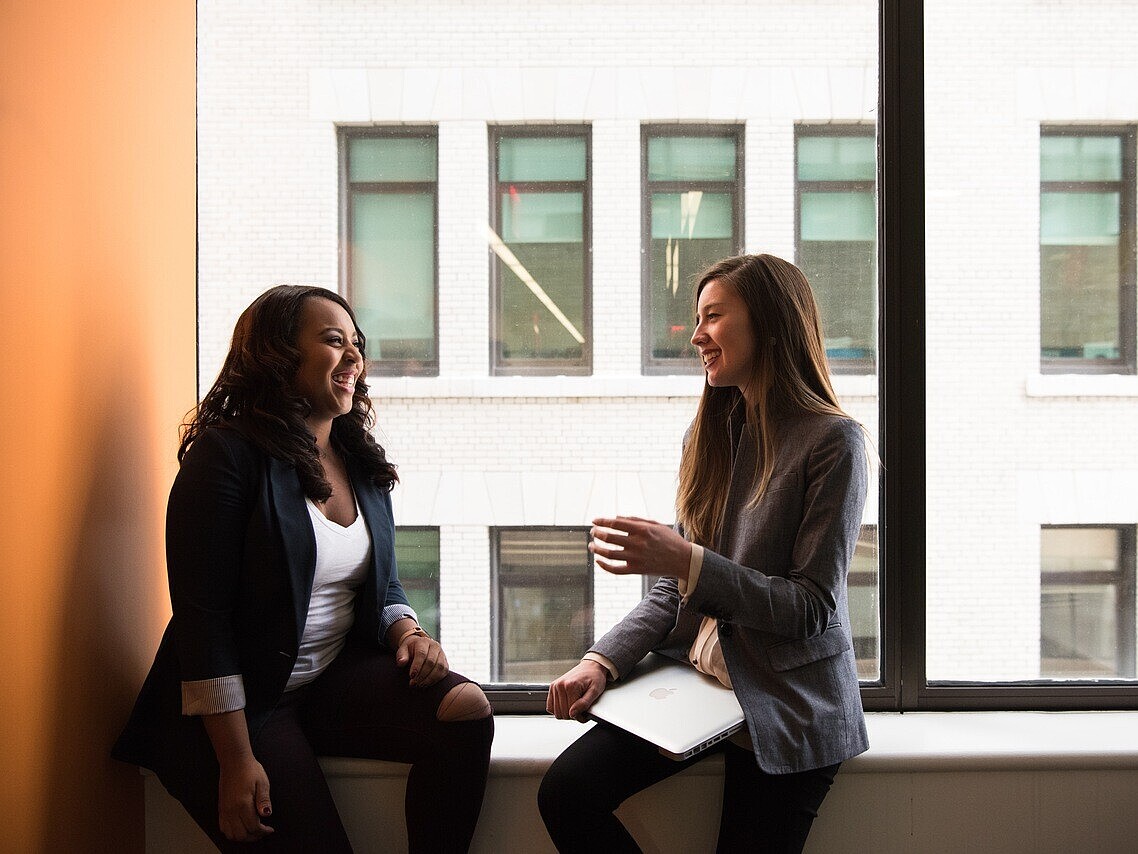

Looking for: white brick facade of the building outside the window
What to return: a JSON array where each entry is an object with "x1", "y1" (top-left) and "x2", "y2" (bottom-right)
[{"x1": 198, "y1": 0, "x2": 1138, "y2": 679}]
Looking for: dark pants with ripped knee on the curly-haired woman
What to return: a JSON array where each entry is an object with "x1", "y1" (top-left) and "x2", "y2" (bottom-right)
[{"x1": 174, "y1": 643, "x2": 494, "y2": 854}]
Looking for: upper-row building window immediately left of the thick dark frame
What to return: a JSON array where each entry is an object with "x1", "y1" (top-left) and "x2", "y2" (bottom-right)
[{"x1": 794, "y1": 124, "x2": 877, "y2": 373}]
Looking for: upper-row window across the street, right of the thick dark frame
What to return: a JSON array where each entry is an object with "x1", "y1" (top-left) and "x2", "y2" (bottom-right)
[{"x1": 1039, "y1": 126, "x2": 1136, "y2": 373}]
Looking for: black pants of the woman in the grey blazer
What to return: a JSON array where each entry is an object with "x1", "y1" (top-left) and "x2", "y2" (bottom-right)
[{"x1": 537, "y1": 723, "x2": 839, "y2": 854}]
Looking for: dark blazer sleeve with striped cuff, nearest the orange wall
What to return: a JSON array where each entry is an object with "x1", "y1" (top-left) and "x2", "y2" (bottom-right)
[{"x1": 166, "y1": 429, "x2": 257, "y2": 701}]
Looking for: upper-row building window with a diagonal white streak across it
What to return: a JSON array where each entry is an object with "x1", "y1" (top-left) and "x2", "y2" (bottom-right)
[{"x1": 489, "y1": 126, "x2": 592, "y2": 373}]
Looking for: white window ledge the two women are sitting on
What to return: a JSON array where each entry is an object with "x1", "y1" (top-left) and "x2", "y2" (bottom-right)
[{"x1": 321, "y1": 712, "x2": 1138, "y2": 778}]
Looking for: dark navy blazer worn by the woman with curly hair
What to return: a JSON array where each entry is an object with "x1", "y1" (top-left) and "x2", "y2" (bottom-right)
[{"x1": 113, "y1": 426, "x2": 414, "y2": 795}]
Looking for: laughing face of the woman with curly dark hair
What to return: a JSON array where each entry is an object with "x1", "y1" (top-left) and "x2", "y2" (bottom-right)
[{"x1": 292, "y1": 297, "x2": 364, "y2": 436}]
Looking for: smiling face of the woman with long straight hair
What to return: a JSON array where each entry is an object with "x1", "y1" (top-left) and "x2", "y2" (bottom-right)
[{"x1": 692, "y1": 279, "x2": 756, "y2": 403}]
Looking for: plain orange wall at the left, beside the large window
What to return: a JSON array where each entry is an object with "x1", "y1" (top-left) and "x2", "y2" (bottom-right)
[{"x1": 0, "y1": 0, "x2": 196, "y2": 852}]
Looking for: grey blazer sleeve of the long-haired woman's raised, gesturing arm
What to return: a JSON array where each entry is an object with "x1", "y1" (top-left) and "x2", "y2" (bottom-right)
[{"x1": 686, "y1": 419, "x2": 868, "y2": 639}]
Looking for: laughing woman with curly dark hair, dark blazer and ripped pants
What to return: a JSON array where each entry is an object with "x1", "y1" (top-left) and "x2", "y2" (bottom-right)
[{"x1": 114, "y1": 285, "x2": 494, "y2": 852}]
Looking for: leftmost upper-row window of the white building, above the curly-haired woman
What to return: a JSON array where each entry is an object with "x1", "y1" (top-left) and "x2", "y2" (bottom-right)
[{"x1": 340, "y1": 129, "x2": 438, "y2": 375}]
